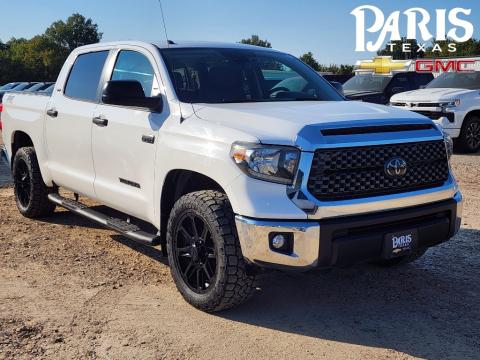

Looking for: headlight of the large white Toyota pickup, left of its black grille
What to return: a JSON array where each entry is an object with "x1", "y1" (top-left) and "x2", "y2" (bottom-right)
[{"x1": 230, "y1": 142, "x2": 300, "y2": 185}]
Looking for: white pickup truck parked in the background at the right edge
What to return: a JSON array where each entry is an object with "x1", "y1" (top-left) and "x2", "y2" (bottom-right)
[{"x1": 390, "y1": 71, "x2": 480, "y2": 153}]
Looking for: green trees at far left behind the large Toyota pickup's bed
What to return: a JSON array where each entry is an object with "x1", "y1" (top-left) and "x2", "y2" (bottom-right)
[{"x1": 0, "y1": 14, "x2": 102, "y2": 84}]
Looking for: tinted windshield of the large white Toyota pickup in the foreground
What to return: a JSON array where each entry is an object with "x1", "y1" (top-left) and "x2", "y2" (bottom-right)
[{"x1": 160, "y1": 48, "x2": 344, "y2": 104}]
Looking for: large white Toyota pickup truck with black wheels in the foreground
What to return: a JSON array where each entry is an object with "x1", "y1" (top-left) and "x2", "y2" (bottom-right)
[{"x1": 1, "y1": 42, "x2": 462, "y2": 311}]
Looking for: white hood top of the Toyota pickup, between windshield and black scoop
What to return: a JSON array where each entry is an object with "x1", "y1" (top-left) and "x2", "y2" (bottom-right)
[{"x1": 193, "y1": 101, "x2": 422, "y2": 145}]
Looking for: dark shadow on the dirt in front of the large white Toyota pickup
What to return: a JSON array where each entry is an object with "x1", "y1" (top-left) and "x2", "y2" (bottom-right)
[{"x1": 217, "y1": 230, "x2": 480, "y2": 359}]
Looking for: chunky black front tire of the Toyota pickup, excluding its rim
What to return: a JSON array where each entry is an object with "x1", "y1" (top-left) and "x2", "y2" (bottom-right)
[{"x1": 167, "y1": 190, "x2": 256, "y2": 312}]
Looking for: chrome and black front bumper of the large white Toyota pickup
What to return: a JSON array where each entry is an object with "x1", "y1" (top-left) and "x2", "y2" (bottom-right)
[{"x1": 236, "y1": 192, "x2": 463, "y2": 270}]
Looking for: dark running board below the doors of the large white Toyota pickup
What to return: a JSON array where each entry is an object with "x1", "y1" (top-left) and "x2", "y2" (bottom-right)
[{"x1": 48, "y1": 194, "x2": 160, "y2": 246}]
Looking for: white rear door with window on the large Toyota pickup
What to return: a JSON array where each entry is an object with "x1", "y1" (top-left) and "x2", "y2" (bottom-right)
[{"x1": 45, "y1": 50, "x2": 109, "y2": 198}]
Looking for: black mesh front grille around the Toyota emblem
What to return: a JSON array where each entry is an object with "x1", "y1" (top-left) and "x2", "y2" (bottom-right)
[{"x1": 308, "y1": 140, "x2": 449, "y2": 200}]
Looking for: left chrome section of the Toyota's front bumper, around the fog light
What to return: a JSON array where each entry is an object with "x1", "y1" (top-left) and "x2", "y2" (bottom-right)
[{"x1": 235, "y1": 215, "x2": 320, "y2": 269}]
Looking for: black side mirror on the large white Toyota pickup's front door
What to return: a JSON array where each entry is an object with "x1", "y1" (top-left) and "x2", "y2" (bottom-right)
[{"x1": 102, "y1": 80, "x2": 163, "y2": 112}]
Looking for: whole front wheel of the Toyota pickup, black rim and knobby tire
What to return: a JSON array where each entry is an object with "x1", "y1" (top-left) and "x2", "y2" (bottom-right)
[{"x1": 167, "y1": 190, "x2": 255, "y2": 312}]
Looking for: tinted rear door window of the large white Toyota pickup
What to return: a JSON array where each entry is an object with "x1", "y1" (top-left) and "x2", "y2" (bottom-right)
[{"x1": 65, "y1": 51, "x2": 108, "y2": 101}]
